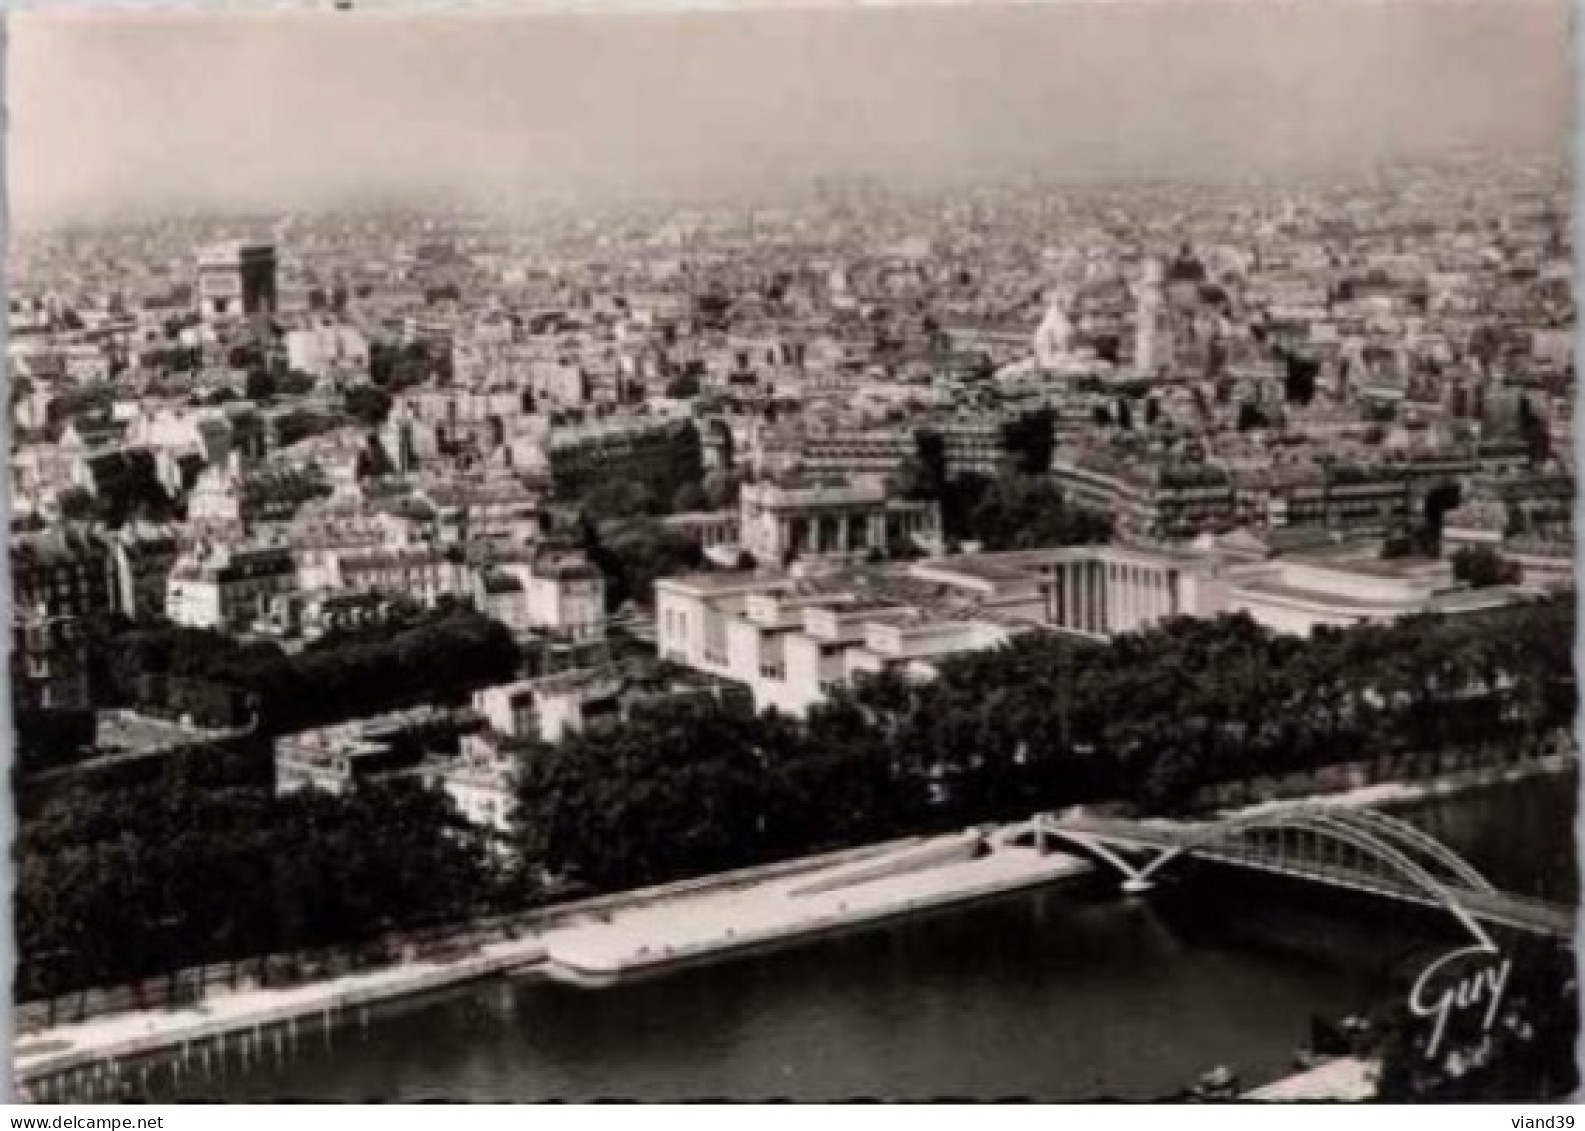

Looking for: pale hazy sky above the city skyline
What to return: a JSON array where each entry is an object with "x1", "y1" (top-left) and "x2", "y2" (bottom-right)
[{"x1": 6, "y1": 0, "x2": 1571, "y2": 220}]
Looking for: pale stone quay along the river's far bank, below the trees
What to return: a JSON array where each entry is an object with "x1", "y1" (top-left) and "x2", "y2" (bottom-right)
[{"x1": 13, "y1": 756, "x2": 1574, "y2": 1099}]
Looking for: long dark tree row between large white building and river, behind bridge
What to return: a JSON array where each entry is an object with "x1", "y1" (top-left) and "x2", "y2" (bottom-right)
[{"x1": 520, "y1": 599, "x2": 1574, "y2": 889}]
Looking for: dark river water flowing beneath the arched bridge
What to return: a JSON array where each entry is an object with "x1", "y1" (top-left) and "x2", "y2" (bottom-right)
[{"x1": 152, "y1": 776, "x2": 1577, "y2": 1101}]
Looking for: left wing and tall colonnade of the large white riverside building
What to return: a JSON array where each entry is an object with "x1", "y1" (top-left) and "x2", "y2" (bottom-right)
[{"x1": 655, "y1": 546, "x2": 1198, "y2": 714}]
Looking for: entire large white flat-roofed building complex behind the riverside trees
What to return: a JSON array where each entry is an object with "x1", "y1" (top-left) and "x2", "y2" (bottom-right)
[{"x1": 655, "y1": 546, "x2": 1514, "y2": 714}]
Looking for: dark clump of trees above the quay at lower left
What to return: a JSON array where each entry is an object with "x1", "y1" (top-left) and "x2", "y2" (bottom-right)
[{"x1": 14, "y1": 766, "x2": 490, "y2": 1001}]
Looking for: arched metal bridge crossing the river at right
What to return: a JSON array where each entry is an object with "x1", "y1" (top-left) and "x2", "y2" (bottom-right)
[{"x1": 1003, "y1": 805, "x2": 1575, "y2": 947}]
